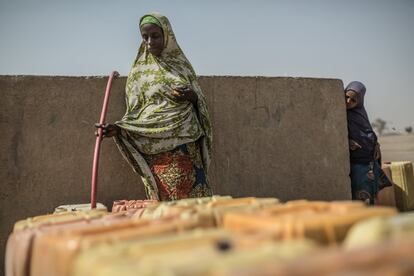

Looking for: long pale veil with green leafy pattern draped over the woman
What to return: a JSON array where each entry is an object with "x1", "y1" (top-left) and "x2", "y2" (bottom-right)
[{"x1": 115, "y1": 13, "x2": 212, "y2": 199}]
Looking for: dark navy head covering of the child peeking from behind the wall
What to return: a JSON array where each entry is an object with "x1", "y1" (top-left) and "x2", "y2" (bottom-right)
[{"x1": 345, "y1": 81, "x2": 377, "y2": 163}]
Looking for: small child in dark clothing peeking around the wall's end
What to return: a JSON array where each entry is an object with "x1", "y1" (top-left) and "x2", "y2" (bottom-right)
[{"x1": 345, "y1": 81, "x2": 392, "y2": 205}]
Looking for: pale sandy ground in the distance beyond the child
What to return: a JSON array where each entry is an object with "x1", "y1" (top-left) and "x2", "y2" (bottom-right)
[{"x1": 379, "y1": 134, "x2": 414, "y2": 163}]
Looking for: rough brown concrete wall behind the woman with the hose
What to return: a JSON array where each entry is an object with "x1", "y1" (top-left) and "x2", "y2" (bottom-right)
[{"x1": 0, "y1": 76, "x2": 350, "y2": 272}]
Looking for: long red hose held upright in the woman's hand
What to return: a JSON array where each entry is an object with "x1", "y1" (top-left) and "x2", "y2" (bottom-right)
[{"x1": 91, "y1": 71, "x2": 119, "y2": 209}]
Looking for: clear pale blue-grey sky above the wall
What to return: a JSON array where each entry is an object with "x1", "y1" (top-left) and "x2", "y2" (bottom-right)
[{"x1": 0, "y1": 0, "x2": 414, "y2": 131}]
